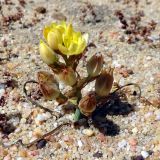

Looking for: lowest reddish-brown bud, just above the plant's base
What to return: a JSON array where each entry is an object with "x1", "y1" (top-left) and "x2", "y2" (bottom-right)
[{"x1": 78, "y1": 92, "x2": 96, "y2": 116}]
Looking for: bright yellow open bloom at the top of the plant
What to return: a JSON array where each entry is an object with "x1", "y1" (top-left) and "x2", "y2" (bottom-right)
[{"x1": 43, "y1": 22, "x2": 88, "y2": 56}]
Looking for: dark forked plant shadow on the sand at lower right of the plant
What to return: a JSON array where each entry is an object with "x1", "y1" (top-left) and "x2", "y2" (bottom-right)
[{"x1": 74, "y1": 94, "x2": 134, "y2": 136}]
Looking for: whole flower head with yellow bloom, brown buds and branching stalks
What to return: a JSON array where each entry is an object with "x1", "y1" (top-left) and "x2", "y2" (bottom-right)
[{"x1": 38, "y1": 22, "x2": 113, "y2": 120}]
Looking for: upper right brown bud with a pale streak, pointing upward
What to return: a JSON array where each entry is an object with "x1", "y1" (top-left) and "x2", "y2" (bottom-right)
[{"x1": 87, "y1": 54, "x2": 103, "y2": 77}]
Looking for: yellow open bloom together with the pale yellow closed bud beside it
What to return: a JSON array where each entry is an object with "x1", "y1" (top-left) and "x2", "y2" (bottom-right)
[{"x1": 40, "y1": 22, "x2": 88, "y2": 64}]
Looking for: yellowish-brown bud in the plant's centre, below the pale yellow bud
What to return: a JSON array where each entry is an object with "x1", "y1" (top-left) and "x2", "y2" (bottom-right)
[{"x1": 57, "y1": 67, "x2": 77, "y2": 86}]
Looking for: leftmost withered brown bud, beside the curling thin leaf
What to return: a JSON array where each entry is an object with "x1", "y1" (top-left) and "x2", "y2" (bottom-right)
[{"x1": 37, "y1": 71, "x2": 60, "y2": 100}]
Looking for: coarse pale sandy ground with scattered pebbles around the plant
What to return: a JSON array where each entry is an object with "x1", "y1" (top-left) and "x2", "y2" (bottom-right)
[{"x1": 0, "y1": 0, "x2": 160, "y2": 160}]
